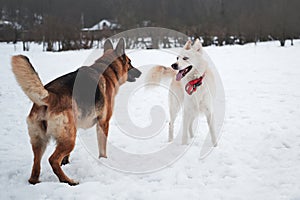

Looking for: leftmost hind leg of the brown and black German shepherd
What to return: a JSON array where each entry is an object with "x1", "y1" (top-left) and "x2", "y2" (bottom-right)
[{"x1": 27, "y1": 116, "x2": 49, "y2": 184}]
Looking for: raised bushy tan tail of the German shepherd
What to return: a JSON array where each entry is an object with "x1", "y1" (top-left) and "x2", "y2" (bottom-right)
[{"x1": 11, "y1": 55, "x2": 49, "y2": 106}]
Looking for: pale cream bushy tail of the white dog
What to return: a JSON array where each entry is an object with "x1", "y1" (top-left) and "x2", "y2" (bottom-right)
[{"x1": 145, "y1": 66, "x2": 176, "y2": 85}]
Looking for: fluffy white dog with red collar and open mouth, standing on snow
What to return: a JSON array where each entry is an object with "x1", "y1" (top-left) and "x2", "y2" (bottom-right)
[{"x1": 146, "y1": 39, "x2": 217, "y2": 146}]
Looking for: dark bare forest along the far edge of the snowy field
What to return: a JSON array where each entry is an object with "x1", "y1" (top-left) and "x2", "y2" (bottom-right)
[{"x1": 0, "y1": 0, "x2": 300, "y2": 50}]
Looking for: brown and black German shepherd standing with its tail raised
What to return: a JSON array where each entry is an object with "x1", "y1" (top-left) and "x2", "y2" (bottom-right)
[{"x1": 12, "y1": 39, "x2": 141, "y2": 185}]
